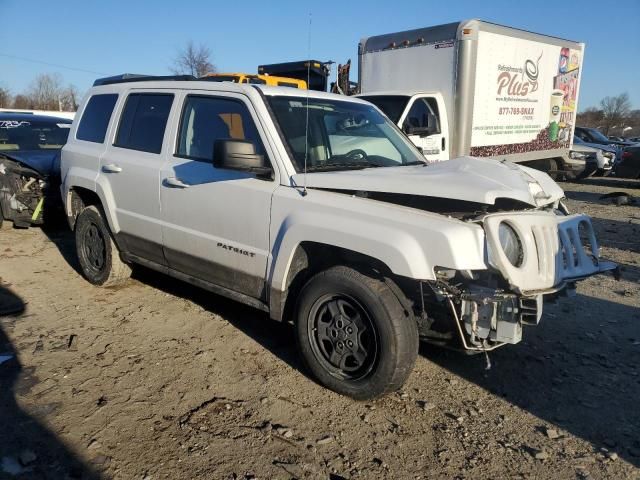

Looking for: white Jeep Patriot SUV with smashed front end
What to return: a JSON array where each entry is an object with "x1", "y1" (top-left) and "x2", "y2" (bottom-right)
[{"x1": 61, "y1": 76, "x2": 616, "y2": 399}]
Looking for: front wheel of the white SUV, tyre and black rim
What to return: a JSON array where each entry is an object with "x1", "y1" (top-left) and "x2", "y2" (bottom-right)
[{"x1": 296, "y1": 266, "x2": 418, "y2": 400}]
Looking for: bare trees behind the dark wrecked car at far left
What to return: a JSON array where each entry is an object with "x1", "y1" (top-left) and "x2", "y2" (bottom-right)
[{"x1": 0, "y1": 73, "x2": 80, "y2": 112}]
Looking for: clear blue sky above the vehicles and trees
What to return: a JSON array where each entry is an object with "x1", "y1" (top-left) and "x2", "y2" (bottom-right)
[{"x1": 0, "y1": 0, "x2": 640, "y2": 110}]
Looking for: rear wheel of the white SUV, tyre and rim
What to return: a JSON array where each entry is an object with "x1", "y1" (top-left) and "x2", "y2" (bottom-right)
[{"x1": 76, "y1": 205, "x2": 131, "y2": 287}]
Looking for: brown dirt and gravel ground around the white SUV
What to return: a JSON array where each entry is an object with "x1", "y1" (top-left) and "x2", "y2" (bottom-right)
[{"x1": 0, "y1": 179, "x2": 640, "y2": 480}]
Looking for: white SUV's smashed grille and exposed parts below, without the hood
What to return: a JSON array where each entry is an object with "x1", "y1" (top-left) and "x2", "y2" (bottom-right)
[{"x1": 419, "y1": 207, "x2": 617, "y2": 352}]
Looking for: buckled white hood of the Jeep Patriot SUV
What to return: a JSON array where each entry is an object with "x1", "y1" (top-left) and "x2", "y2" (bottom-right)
[{"x1": 293, "y1": 157, "x2": 564, "y2": 207}]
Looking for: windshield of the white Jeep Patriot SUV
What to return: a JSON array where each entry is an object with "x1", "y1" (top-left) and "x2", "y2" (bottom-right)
[{"x1": 267, "y1": 96, "x2": 426, "y2": 172}]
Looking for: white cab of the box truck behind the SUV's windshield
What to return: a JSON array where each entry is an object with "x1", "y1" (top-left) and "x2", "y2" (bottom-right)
[{"x1": 358, "y1": 91, "x2": 451, "y2": 162}]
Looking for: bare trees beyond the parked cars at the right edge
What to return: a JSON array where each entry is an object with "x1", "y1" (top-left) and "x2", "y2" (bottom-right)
[{"x1": 576, "y1": 93, "x2": 640, "y2": 138}]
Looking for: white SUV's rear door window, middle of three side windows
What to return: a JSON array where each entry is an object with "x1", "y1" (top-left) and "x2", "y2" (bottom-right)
[{"x1": 115, "y1": 93, "x2": 173, "y2": 153}]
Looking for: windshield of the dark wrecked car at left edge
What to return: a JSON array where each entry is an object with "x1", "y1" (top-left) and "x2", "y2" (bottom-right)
[{"x1": 0, "y1": 119, "x2": 71, "y2": 151}]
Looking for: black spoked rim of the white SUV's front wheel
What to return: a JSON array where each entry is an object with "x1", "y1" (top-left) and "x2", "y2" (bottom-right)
[{"x1": 308, "y1": 294, "x2": 378, "y2": 380}]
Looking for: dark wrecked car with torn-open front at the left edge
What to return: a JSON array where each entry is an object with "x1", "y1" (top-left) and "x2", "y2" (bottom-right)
[{"x1": 0, "y1": 113, "x2": 71, "y2": 227}]
